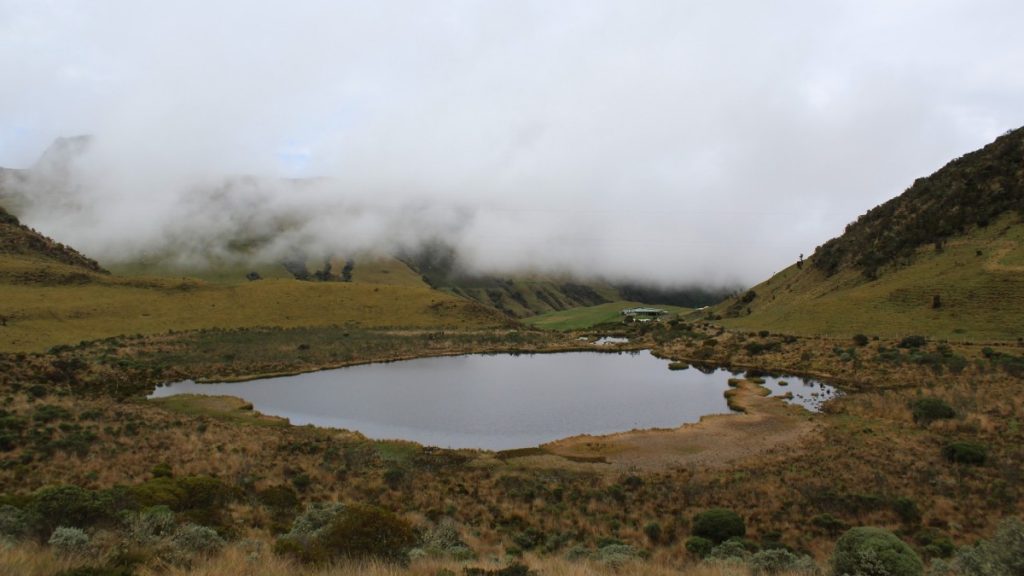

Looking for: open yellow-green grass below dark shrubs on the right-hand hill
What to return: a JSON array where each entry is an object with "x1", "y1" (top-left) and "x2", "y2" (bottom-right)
[{"x1": 716, "y1": 213, "x2": 1024, "y2": 340}]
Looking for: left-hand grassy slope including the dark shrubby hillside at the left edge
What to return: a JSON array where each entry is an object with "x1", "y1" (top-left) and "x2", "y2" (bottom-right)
[{"x1": 0, "y1": 203, "x2": 507, "y2": 352}]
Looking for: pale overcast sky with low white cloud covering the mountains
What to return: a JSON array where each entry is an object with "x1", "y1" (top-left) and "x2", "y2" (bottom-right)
[{"x1": 0, "y1": 0, "x2": 1024, "y2": 283}]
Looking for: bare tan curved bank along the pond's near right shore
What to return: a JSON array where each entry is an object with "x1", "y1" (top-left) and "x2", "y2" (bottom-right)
[{"x1": 534, "y1": 380, "x2": 816, "y2": 470}]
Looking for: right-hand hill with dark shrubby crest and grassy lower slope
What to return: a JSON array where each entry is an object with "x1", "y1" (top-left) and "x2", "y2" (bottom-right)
[{"x1": 713, "y1": 128, "x2": 1024, "y2": 340}]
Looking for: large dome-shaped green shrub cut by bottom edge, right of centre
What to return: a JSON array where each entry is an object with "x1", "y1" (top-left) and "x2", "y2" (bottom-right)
[{"x1": 831, "y1": 527, "x2": 925, "y2": 576}]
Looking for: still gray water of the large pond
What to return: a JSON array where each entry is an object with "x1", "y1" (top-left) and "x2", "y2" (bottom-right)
[{"x1": 151, "y1": 351, "x2": 833, "y2": 450}]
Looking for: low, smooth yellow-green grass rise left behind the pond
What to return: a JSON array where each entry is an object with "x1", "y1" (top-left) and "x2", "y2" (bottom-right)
[{"x1": 0, "y1": 268, "x2": 504, "y2": 352}]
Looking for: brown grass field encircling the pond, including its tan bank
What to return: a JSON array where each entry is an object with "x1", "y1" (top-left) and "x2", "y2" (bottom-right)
[{"x1": 0, "y1": 317, "x2": 1024, "y2": 574}]
